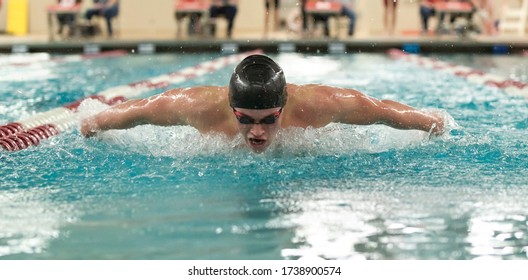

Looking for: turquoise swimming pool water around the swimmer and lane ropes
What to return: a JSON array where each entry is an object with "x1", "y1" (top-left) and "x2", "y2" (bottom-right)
[{"x1": 0, "y1": 50, "x2": 528, "y2": 259}]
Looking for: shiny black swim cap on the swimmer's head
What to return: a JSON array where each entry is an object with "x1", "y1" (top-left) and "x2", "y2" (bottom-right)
[{"x1": 229, "y1": 55, "x2": 286, "y2": 109}]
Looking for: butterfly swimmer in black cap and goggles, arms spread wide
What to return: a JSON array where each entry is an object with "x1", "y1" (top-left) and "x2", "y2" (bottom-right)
[{"x1": 80, "y1": 55, "x2": 444, "y2": 153}]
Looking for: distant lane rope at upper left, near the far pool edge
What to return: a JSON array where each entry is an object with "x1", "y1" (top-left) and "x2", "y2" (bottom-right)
[{"x1": 0, "y1": 50, "x2": 128, "y2": 66}]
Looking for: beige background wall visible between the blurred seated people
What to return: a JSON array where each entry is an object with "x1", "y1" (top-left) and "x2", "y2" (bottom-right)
[{"x1": 0, "y1": 0, "x2": 508, "y2": 38}]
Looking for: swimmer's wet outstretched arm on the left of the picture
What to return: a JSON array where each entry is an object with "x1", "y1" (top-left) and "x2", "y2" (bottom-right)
[{"x1": 80, "y1": 89, "x2": 194, "y2": 137}]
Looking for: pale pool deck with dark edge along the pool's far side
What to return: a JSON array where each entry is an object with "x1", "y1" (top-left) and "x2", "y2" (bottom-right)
[{"x1": 0, "y1": 29, "x2": 528, "y2": 54}]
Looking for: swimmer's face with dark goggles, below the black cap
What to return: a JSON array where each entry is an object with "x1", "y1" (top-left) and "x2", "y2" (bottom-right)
[{"x1": 233, "y1": 107, "x2": 282, "y2": 153}]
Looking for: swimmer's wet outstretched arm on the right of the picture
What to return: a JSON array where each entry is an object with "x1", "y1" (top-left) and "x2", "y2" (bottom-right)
[{"x1": 337, "y1": 88, "x2": 444, "y2": 135}]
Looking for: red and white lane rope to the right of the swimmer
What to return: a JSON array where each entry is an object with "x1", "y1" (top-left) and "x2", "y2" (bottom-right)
[{"x1": 388, "y1": 49, "x2": 528, "y2": 98}]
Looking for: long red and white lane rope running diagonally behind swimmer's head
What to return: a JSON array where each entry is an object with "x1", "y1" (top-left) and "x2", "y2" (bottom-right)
[{"x1": 0, "y1": 50, "x2": 262, "y2": 151}]
